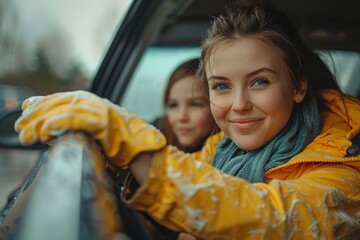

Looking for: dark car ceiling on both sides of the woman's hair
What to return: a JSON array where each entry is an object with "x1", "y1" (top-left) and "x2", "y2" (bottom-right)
[{"x1": 154, "y1": 0, "x2": 360, "y2": 51}]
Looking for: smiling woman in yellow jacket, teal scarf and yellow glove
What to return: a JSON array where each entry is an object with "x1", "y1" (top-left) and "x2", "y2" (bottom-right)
[{"x1": 16, "y1": 1, "x2": 360, "y2": 239}]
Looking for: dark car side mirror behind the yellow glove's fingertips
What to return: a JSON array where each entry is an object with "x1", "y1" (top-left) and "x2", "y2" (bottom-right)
[{"x1": 0, "y1": 109, "x2": 48, "y2": 149}]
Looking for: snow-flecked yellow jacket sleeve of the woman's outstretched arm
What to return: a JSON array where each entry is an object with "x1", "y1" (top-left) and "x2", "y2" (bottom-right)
[{"x1": 126, "y1": 146, "x2": 360, "y2": 239}]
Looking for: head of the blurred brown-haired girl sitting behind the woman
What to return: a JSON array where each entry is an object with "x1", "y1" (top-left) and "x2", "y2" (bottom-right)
[{"x1": 154, "y1": 59, "x2": 216, "y2": 153}]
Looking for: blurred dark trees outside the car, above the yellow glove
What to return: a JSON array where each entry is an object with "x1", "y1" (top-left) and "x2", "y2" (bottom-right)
[{"x1": 0, "y1": 0, "x2": 88, "y2": 94}]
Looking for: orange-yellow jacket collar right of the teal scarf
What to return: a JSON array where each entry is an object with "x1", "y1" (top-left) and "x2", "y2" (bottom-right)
[{"x1": 266, "y1": 90, "x2": 360, "y2": 177}]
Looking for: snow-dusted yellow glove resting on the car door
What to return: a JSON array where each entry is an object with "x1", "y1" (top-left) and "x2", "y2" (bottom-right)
[{"x1": 15, "y1": 91, "x2": 166, "y2": 167}]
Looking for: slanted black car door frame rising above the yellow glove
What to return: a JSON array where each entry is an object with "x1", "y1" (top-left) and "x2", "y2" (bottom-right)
[{"x1": 89, "y1": 0, "x2": 193, "y2": 103}]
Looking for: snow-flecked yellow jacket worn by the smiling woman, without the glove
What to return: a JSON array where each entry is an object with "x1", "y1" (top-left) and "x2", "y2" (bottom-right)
[{"x1": 126, "y1": 90, "x2": 360, "y2": 239}]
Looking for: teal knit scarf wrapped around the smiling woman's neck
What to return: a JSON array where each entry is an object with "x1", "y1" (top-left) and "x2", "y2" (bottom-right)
[{"x1": 212, "y1": 102, "x2": 321, "y2": 183}]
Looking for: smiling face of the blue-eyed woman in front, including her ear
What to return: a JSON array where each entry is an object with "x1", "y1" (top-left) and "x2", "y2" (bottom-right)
[{"x1": 206, "y1": 38, "x2": 306, "y2": 151}]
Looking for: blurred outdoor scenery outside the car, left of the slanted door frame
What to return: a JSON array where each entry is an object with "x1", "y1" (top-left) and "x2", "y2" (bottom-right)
[{"x1": 0, "y1": 0, "x2": 131, "y2": 206}]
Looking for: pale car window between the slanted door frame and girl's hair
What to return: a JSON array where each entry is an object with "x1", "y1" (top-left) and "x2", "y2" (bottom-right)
[{"x1": 119, "y1": 47, "x2": 200, "y2": 122}]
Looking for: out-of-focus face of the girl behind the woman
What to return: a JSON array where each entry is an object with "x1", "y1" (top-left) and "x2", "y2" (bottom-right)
[{"x1": 167, "y1": 76, "x2": 214, "y2": 147}]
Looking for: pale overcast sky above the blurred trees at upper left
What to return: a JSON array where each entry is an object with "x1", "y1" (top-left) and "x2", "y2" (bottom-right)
[{"x1": 11, "y1": 0, "x2": 132, "y2": 77}]
